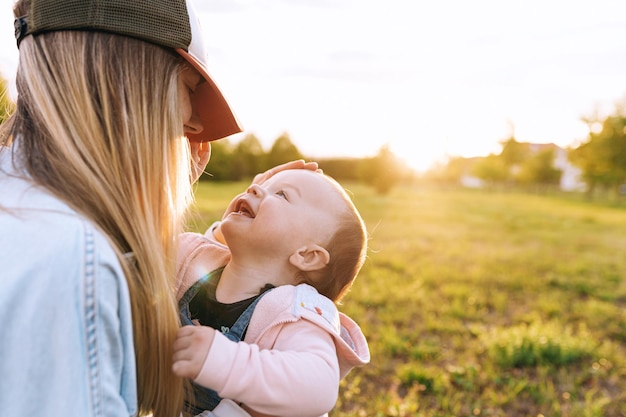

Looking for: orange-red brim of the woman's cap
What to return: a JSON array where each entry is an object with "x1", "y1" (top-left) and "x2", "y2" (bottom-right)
[{"x1": 176, "y1": 48, "x2": 242, "y2": 142}]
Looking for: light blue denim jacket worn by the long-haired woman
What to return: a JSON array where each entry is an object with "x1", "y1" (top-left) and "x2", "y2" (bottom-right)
[{"x1": 0, "y1": 147, "x2": 137, "y2": 417}]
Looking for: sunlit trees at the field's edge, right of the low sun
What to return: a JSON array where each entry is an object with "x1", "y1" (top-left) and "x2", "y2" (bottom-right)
[{"x1": 427, "y1": 97, "x2": 626, "y2": 197}]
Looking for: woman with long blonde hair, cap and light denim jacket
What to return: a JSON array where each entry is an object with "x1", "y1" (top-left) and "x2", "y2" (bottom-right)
[{"x1": 0, "y1": 0, "x2": 240, "y2": 417}]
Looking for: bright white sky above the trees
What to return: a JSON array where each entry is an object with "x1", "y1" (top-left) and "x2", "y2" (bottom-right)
[{"x1": 0, "y1": 0, "x2": 626, "y2": 170}]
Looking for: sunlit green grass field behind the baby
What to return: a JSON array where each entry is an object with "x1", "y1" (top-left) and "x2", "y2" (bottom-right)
[{"x1": 192, "y1": 183, "x2": 626, "y2": 417}]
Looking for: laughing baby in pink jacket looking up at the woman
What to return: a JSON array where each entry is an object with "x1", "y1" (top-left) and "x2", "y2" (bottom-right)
[{"x1": 173, "y1": 169, "x2": 370, "y2": 416}]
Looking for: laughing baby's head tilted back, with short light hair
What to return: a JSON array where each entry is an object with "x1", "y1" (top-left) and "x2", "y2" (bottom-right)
[{"x1": 222, "y1": 169, "x2": 367, "y2": 302}]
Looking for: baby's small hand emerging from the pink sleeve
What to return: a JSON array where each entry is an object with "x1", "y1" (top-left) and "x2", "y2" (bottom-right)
[{"x1": 172, "y1": 326, "x2": 215, "y2": 379}]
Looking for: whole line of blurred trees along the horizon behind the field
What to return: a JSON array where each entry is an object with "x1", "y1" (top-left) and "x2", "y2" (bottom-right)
[{"x1": 0, "y1": 69, "x2": 626, "y2": 196}]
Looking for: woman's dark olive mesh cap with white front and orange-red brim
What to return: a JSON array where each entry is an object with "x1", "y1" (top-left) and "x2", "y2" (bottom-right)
[{"x1": 15, "y1": 0, "x2": 241, "y2": 142}]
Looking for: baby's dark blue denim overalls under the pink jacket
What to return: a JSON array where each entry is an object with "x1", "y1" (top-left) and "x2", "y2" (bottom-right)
[{"x1": 178, "y1": 270, "x2": 268, "y2": 415}]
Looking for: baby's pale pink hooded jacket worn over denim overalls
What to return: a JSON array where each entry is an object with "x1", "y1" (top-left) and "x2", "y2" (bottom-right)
[{"x1": 177, "y1": 231, "x2": 370, "y2": 417}]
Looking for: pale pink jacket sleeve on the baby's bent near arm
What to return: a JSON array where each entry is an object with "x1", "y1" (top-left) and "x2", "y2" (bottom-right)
[{"x1": 195, "y1": 320, "x2": 339, "y2": 417}]
